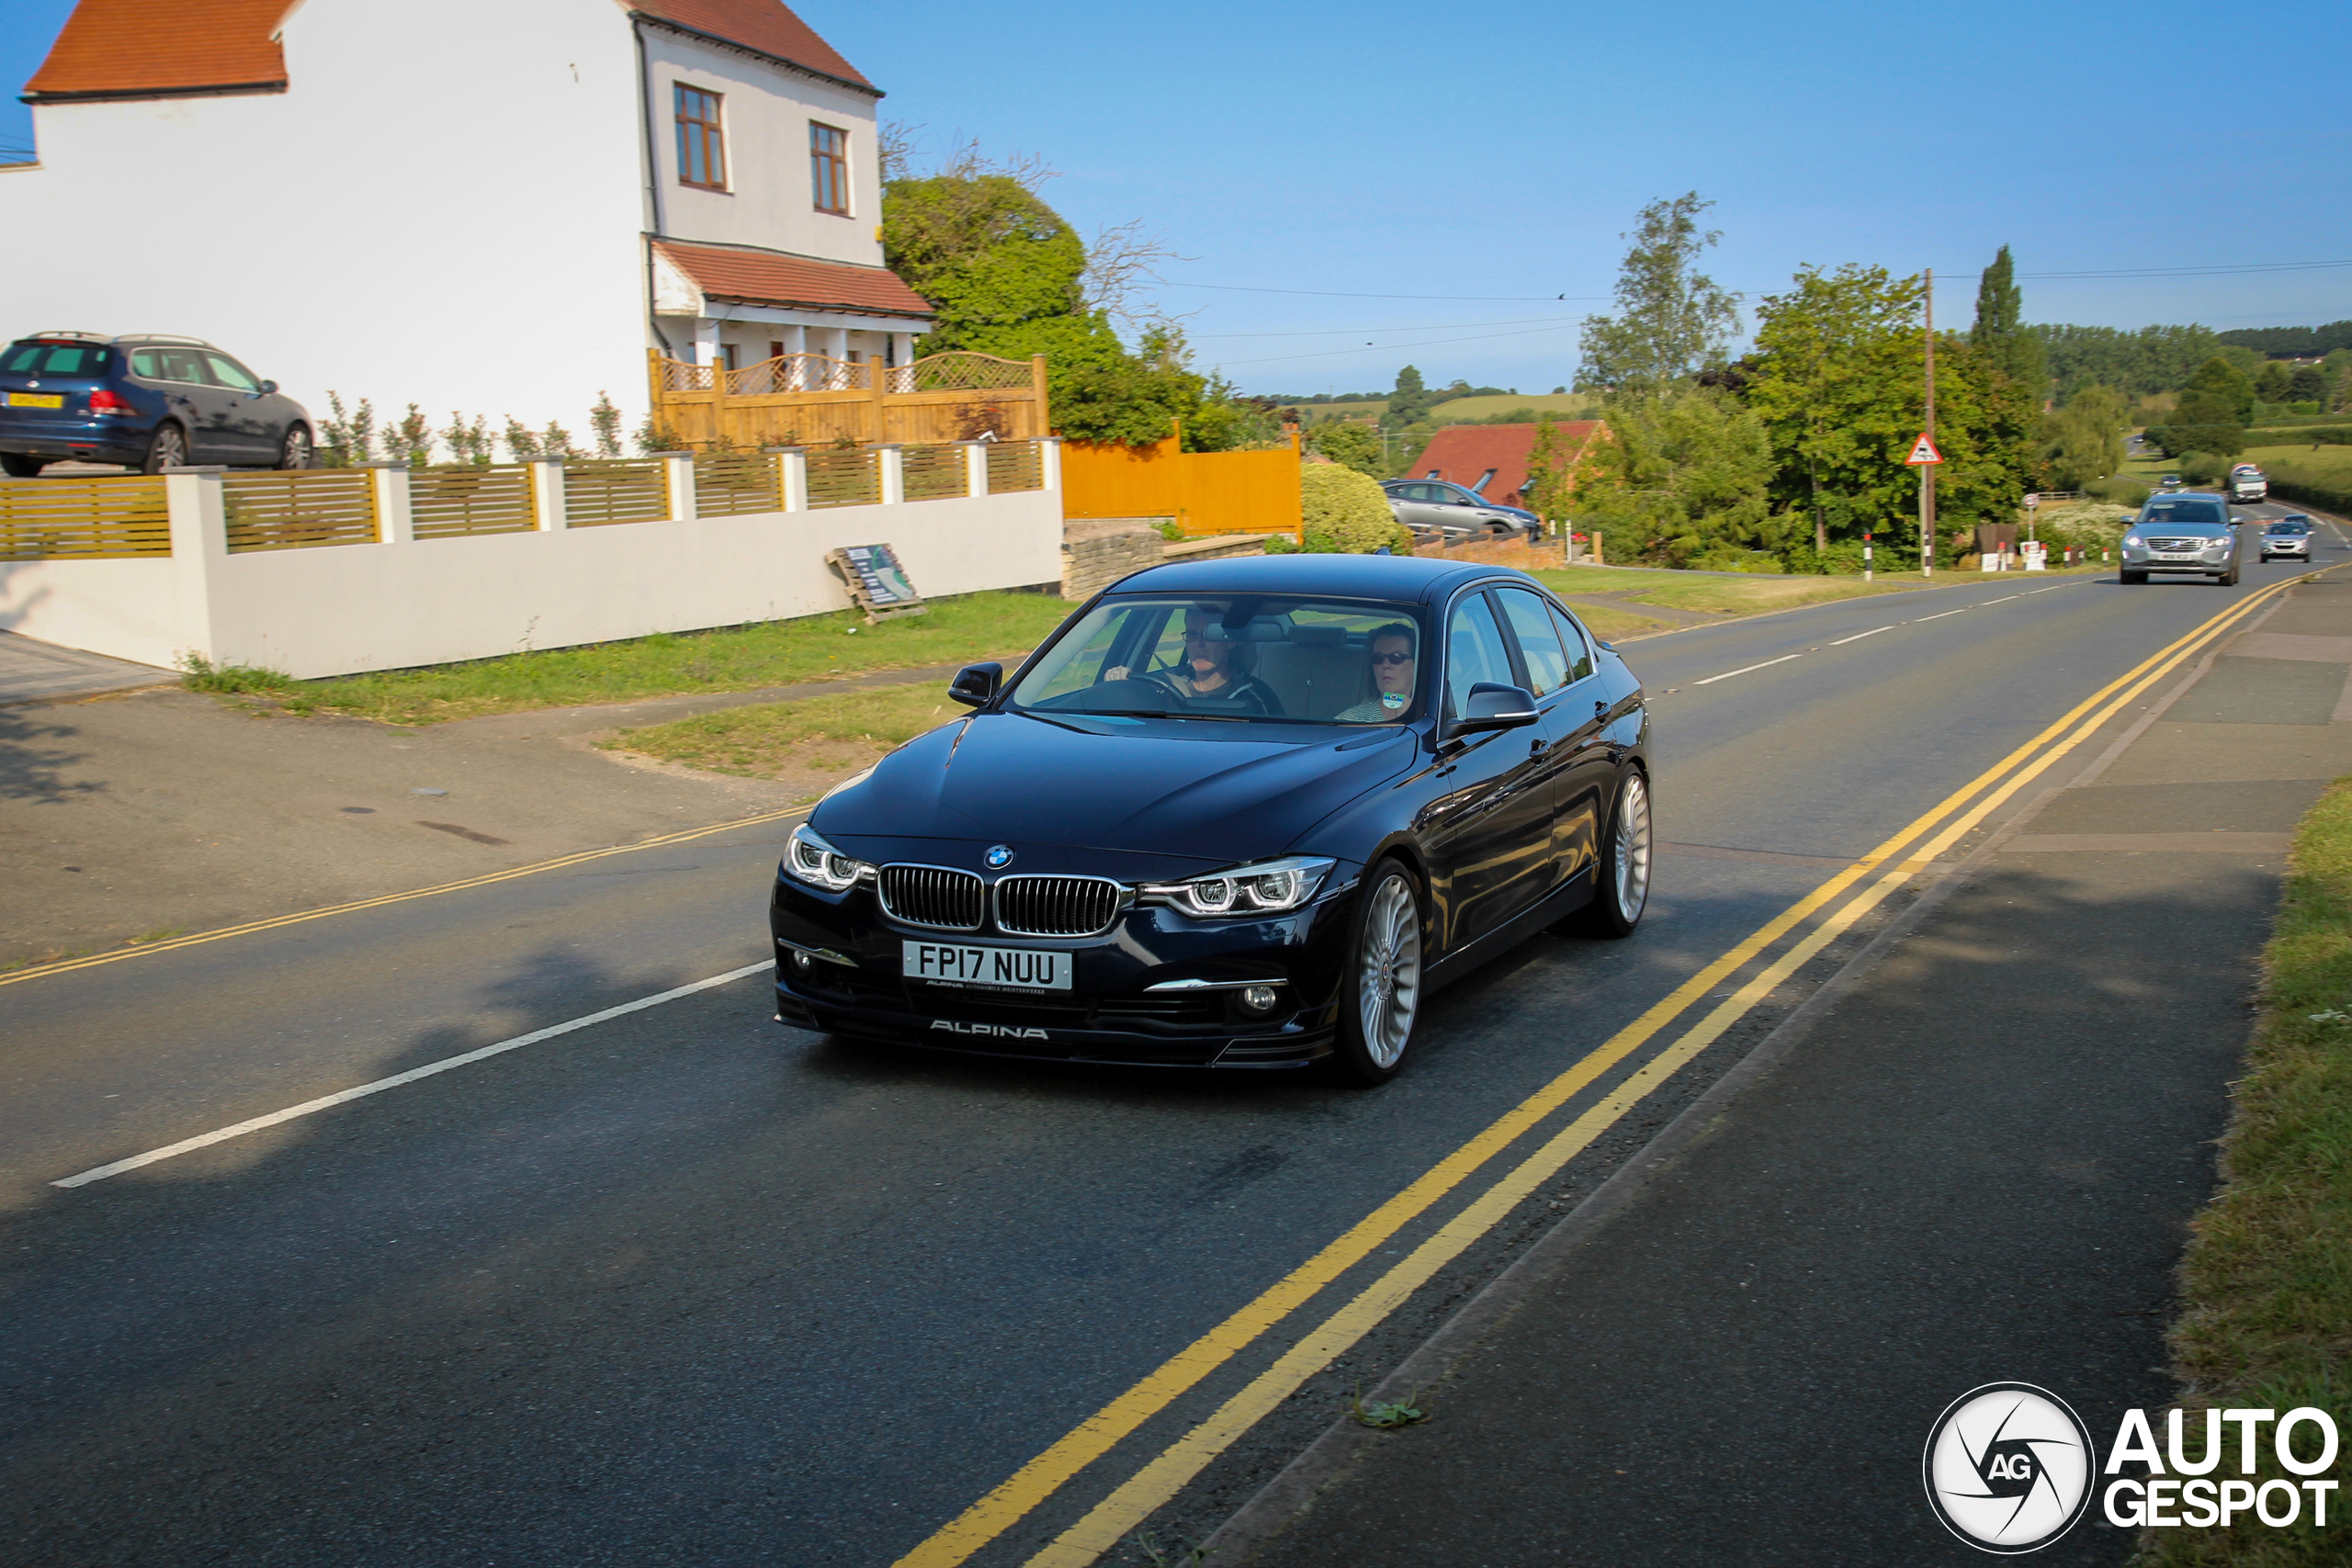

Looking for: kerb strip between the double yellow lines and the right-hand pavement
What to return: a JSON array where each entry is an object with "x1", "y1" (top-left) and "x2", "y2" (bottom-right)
[{"x1": 1200, "y1": 569, "x2": 2324, "y2": 1568}]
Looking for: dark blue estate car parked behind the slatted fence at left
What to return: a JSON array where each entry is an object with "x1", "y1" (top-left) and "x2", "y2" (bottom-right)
[{"x1": 0, "y1": 332, "x2": 312, "y2": 479}]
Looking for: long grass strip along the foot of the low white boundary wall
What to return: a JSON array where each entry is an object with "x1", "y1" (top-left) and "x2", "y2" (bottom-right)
[{"x1": 188, "y1": 592, "x2": 1072, "y2": 724}]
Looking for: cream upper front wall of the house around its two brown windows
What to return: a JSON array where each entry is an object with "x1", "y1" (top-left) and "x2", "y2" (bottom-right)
[{"x1": 644, "y1": 24, "x2": 882, "y2": 265}]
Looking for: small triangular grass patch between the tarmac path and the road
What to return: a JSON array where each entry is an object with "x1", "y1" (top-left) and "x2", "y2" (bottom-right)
[{"x1": 605, "y1": 682, "x2": 965, "y2": 790}]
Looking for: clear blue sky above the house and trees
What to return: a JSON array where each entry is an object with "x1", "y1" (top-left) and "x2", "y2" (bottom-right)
[{"x1": 0, "y1": 0, "x2": 2352, "y2": 392}]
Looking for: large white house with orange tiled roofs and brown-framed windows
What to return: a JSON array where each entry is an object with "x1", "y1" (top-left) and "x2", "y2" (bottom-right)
[{"x1": 0, "y1": 0, "x2": 929, "y2": 453}]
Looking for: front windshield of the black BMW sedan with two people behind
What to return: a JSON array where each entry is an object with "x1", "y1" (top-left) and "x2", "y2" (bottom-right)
[{"x1": 1012, "y1": 594, "x2": 1423, "y2": 724}]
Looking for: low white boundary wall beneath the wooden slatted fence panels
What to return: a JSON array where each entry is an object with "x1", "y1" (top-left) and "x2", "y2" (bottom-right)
[{"x1": 0, "y1": 479, "x2": 1061, "y2": 677}]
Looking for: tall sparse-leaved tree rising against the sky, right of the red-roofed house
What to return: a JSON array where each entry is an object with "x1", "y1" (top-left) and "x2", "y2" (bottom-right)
[{"x1": 1576, "y1": 190, "x2": 1740, "y2": 390}]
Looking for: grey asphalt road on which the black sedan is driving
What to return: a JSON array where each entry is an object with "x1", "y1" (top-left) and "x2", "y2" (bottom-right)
[{"x1": 0, "y1": 508, "x2": 2352, "y2": 1568}]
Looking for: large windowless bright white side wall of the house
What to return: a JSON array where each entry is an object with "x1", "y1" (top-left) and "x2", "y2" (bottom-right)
[{"x1": 0, "y1": 0, "x2": 653, "y2": 446}]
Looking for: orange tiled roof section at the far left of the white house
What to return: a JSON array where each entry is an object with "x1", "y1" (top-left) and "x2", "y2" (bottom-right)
[{"x1": 24, "y1": 0, "x2": 294, "y2": 101}]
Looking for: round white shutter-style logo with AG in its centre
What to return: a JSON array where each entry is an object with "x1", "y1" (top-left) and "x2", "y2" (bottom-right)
[{"x1": 1919, "y1": 1382, "x2": 2098, "y2": 1556}]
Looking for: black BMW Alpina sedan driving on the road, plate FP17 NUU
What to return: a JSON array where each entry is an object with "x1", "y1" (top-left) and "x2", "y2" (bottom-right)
[{"x1": 769, "y1": 555, "x2": 1651, "y2": 1084}]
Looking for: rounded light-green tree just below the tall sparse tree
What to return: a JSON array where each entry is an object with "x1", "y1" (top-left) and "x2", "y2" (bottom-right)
[{"x1": 1576, "y1": 388, "x2": 1773, "y2": 567}]
